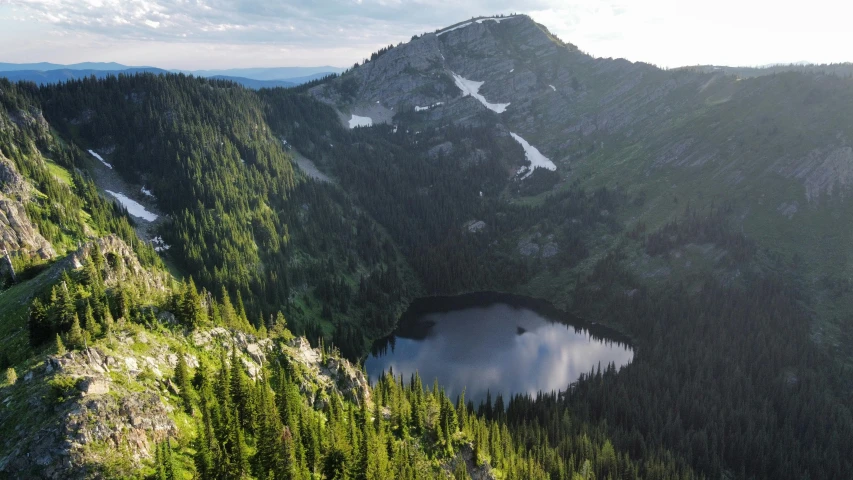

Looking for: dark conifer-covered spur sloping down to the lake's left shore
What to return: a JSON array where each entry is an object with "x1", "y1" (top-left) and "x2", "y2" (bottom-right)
[{"x1": 35, "y1": 75, "x2": 417, "y2": 356}]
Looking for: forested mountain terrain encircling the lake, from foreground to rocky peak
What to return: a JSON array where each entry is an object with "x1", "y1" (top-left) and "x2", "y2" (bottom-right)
[{"x1": 0, "y1": 15, "x2": 853, "y2": 480}]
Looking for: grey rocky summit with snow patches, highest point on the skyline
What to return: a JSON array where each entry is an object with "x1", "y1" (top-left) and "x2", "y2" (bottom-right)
[{"x1": 312, "y1": 11, "x2": 577, "y2": 127}]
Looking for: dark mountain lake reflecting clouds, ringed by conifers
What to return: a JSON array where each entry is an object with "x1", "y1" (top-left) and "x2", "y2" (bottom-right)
[{"x1": 365, "y1": 293, "x2": 634, "y2": 403}]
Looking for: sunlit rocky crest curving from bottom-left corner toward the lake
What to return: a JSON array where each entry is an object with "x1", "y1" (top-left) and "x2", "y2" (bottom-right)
[{"x1": 0, "y1": 324, "x2": 369, "y2": 479}]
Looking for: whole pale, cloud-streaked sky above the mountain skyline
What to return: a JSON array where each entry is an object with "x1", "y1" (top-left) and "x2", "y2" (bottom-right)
[{"x1": 0, "y1": 0, "x2": 853, "y2": 69}]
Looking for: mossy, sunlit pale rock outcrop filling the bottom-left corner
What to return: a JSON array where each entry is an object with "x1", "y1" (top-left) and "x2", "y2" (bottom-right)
[{"x1": 0, "y1": 348, "x2": 177, "y2": 479}]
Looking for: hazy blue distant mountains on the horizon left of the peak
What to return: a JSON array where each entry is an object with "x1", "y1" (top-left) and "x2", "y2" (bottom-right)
[{"x1": 0, "y1": 62, "x2": 343, "y2": 90}]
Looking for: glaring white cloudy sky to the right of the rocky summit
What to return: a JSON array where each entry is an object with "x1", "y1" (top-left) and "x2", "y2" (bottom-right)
[{"x1": 530, "y1": 0, "x2": 853, "y2": 67}]
